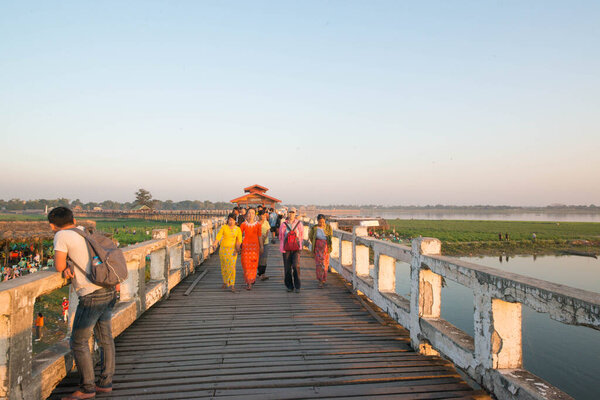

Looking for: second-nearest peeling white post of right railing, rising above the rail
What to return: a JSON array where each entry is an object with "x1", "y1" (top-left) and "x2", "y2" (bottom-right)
[{"x1": 409, "y1": 238, "x2": 442, "y2": 353}]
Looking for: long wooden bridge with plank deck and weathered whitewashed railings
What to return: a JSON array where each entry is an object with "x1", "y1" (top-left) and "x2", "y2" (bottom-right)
[{"x1": 0, "y1": 219, "x2": 600, "y2": 399}]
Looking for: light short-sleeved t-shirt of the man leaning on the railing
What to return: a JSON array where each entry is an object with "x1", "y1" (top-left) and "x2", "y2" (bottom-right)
[{"x1": 54, "y1": 226, "x2": 102, "y2": 297}]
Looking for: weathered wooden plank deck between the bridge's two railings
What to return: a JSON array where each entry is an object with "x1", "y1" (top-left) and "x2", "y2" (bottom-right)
[{"x1": 51, "y1": 245, "x2": 487, "y2": 400}]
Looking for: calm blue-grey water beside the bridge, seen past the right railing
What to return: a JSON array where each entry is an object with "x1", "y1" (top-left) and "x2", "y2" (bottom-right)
[{"x1": 396, "y1": 256, "x2": 600, "y2": 399}]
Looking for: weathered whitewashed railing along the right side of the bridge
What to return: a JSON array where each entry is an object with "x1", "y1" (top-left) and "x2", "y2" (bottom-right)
[{"x1": 305, "y1": 221, "x2": 600, "y2": 399}]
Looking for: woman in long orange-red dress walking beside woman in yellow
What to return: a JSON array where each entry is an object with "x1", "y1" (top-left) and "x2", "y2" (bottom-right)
[{"x1": 240, "y1": 208, "x2": 263, "y2": 290}]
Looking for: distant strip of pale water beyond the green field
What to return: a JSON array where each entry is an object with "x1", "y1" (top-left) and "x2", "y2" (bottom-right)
[{"x1": 361, "y1": 210, "x2": 600, "y2": 222}]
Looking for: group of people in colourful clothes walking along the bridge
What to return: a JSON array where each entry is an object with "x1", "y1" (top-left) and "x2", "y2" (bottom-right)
[{"x1": 212, "y1": 207, "x2": 333, "y2": 292}]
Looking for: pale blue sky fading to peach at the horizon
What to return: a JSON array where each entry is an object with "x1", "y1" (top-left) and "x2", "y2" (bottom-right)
[{"x1": 0, "y1": 1, "x2": 600, "y2": 205}]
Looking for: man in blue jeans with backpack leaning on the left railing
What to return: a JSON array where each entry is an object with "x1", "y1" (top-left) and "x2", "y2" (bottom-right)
[{"x1": 48, "y1": 207, "x2": 127, "y2": 400}]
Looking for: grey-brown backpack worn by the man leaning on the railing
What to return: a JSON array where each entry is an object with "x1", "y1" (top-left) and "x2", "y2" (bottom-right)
[{"x1": 69, "y1": 228, "x2": 127, "y2": 287}]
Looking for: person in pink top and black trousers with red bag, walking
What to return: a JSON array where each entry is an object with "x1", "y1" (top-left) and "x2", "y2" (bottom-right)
[{"x1": 279, "y1": 207, "x2": 304, "y2": 293}]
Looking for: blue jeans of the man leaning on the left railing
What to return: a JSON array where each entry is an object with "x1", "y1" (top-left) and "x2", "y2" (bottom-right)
[{"x1": 70, "y1": 288, "x2": 117, "y2": 393}]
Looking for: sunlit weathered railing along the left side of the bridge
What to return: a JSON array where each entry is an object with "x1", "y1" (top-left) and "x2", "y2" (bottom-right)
[{"x1": 0, "y1": 218, "x2": 224, "y2": 399}]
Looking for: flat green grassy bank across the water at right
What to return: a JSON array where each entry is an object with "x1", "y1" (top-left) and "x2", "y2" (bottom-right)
[{"x1": 388, "y1": 219, "x2": 600, "y2": 255}]
